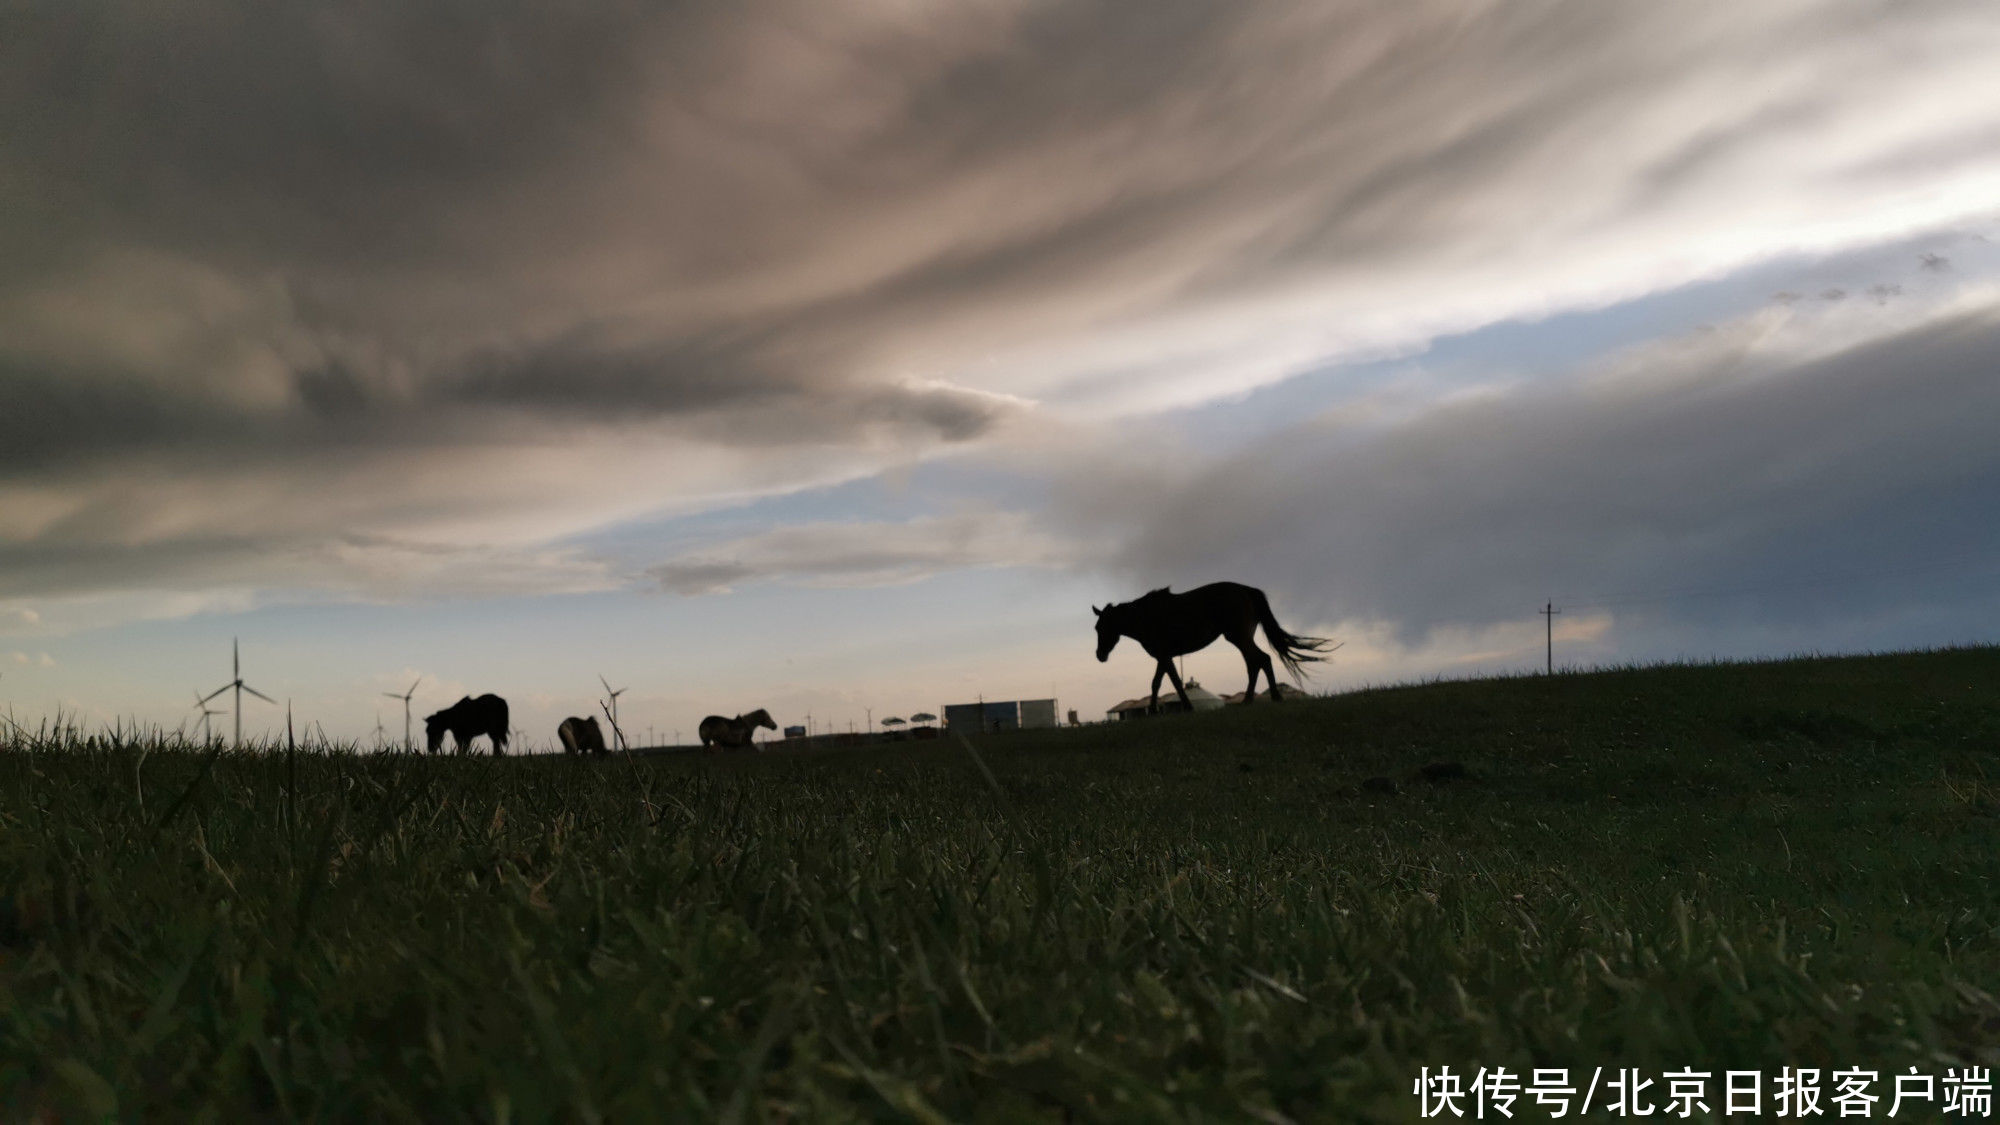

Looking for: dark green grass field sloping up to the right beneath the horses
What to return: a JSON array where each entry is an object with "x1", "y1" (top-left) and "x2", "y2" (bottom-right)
[{"x1": 0, "y1": 649, "x2": 2000, "y2": 1121}]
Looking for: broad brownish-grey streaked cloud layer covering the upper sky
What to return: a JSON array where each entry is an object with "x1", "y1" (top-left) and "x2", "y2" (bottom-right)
[{"x1": 0, "y1": 0, "x2": 2000, "y2": 595}]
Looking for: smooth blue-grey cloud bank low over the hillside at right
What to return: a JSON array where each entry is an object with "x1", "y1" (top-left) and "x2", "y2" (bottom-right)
[{"x1": 1082, "y1": 308, "x2": 2000, "y2": 639}]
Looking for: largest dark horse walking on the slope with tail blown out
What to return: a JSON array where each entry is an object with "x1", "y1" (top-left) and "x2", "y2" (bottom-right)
[{"x1": 1090, "y1": 583, "x2": 1338, "y2": 711}]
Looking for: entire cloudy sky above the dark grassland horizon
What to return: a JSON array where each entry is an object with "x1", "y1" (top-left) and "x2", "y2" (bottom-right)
[{"x1": 0, "y1": 0, "x2": 2000, "y2": 747}]
